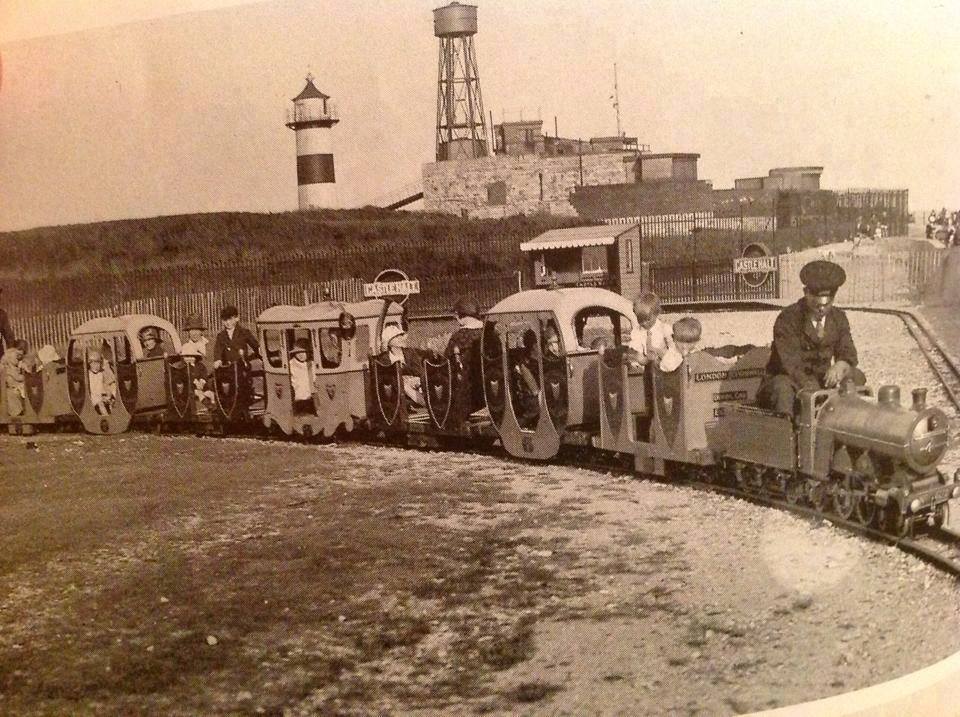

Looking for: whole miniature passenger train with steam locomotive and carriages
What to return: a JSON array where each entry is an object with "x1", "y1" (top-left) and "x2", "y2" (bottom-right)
[{"x1": 0, "y1": 288, "x2": 960, "y2": 535}]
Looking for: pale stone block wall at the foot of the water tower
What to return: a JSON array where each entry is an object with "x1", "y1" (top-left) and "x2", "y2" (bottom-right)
[{"x1": 423, "y1": 153, "x2": 633, "y2": 218}]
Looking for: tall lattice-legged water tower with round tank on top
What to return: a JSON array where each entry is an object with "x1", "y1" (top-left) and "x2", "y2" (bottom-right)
[{"x1": 433, "y1": 2, "x2": 487, "y2": 162}]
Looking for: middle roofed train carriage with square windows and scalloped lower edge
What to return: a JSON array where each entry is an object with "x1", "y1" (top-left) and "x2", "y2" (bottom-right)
[{"x1": 257, "y1": 299, "x2": 401, "y2": 437}]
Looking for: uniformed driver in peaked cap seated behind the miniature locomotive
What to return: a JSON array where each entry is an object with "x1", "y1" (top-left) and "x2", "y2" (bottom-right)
[{"x1": 757, "y1": 260, "x2": 866, "y2": 415}]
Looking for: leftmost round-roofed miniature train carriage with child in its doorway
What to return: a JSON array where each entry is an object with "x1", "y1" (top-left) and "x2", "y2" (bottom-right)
[{"x1": 66, "y1": 314, "x2": 187, "y2": 434}]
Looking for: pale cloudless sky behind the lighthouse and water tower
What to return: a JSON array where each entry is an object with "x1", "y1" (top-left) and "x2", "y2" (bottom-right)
[{"x1": 0, "y1": 0, "x2": 960, "y2": 231}]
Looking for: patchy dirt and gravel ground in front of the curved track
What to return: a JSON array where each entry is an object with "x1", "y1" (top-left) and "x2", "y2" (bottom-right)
[{"x1": 0, "y1": 434, "x2": 960, "y2": 715}]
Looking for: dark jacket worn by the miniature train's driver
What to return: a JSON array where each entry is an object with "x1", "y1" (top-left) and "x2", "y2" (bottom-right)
[{"x1": 767, "y1": 299, "x2": 857, "y2": 388}]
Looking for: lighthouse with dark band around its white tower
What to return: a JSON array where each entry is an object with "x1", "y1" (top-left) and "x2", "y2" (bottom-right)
[{"x1": 287, "y1": 73, "x2": 340, "y2": 210}]
